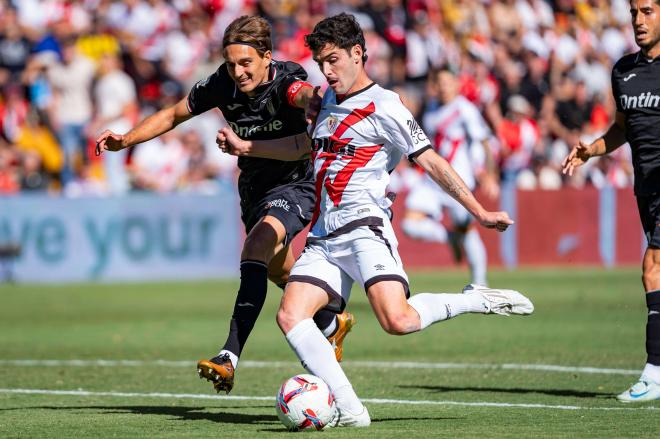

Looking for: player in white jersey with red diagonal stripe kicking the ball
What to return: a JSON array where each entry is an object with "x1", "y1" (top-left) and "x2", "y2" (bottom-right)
[{"x1": 221, "y1": 13, "x2": 534, "y2": 427}]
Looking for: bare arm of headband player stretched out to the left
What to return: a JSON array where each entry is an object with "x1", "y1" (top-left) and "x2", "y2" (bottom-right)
[{"x1": 96, "y1": 97, "x2": 193, "y2": 155}]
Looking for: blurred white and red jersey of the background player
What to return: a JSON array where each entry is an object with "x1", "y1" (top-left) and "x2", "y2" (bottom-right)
[{"x1": 423, "y1": 96, "x2": 491, "y2": 190}]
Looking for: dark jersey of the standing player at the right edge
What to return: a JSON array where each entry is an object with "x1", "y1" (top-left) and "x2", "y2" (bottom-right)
[{"x1": 612, "y1": 52, "x2": 660, "y2": 195}]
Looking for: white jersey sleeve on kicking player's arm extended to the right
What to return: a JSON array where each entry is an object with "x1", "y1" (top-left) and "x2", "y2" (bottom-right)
[{"x1": 381, "y1": 94, "x2": 431, "y2": 161}]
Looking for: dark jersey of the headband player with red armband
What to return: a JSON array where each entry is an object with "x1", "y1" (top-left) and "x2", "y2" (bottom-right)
[{"x1": 188, "y1": 61, "x2": 313, "y2": 205}]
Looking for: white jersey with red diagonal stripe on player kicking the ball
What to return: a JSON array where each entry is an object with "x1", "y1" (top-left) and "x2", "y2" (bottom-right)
[{"x1": 310, "y1": 83, "x2": 431, "y2": 237}]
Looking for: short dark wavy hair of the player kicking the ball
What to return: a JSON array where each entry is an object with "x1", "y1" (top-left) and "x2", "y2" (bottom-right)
[{"x1": 305, "y1": 12, "x2": 368, "y2": 63}]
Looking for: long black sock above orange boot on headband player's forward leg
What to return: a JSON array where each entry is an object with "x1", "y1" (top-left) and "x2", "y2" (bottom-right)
[{"x1": 223, "y1": 260, "x2": 268, "y2": 357}]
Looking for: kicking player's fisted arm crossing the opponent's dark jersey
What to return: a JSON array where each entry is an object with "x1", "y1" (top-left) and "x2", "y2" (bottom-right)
[{"x1": 215, "y1": 127, "x2": 311, "y2": 161}]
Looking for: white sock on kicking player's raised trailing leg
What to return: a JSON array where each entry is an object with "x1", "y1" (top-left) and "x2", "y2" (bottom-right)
[{"x1": 408, "y1": 293, "x2": 488, "y2": 330}]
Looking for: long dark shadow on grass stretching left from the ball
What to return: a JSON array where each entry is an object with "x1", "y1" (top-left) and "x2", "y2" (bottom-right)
[{"x1": 0, "y1": 405, "x2": 279, "y2": 425}]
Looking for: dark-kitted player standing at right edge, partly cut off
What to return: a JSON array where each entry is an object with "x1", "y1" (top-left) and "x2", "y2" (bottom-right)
[{"x1": 563, "y1": 0, "x2": 660, "y2": 402}]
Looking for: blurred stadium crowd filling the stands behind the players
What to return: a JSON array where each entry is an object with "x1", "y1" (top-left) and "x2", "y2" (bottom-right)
[{"x1": 0, "y1": 0, "x2": 636, "y2": 196}]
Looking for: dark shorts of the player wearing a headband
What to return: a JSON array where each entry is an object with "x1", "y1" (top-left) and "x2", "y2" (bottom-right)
[{"x1": 241, "y1": 183, "x2": 315, "y2": 245}]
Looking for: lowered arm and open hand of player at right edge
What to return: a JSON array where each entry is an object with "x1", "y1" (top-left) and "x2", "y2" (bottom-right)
[{"x1": 561, "y1": 112, "x2": 626, "y2": 175}]
